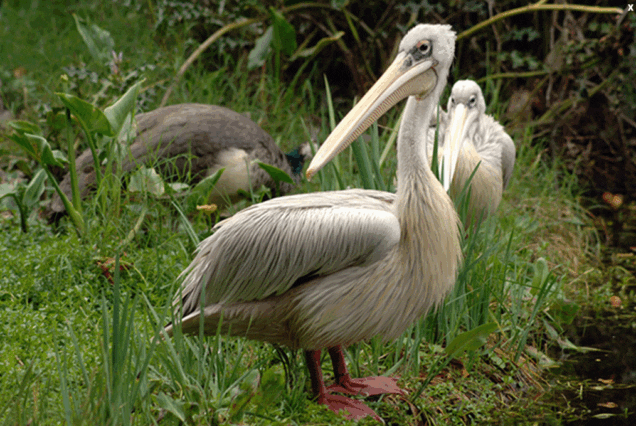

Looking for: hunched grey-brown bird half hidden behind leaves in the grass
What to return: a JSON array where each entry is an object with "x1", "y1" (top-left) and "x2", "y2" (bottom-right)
[{"x1": 47, "y1": 103, "x2": 311, "y2": 215}]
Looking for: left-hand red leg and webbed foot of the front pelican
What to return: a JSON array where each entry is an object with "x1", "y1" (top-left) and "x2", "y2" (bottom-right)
[{"x1": 305, "y1": 350, "x2": 384, "y2": 423}]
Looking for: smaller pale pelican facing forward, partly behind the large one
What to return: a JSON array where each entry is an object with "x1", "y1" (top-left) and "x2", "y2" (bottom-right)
[{"x1": 429, "y1": 80, "x2": 515, "y2": 226}]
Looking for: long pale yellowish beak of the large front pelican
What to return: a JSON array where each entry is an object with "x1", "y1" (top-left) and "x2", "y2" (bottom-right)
[{"x1": 306, "y1": 52, "x2": 437, "y2": 179}]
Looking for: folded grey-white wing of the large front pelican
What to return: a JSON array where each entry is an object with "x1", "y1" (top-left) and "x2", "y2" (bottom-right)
[{"x1": 177, "y1": 189, "x2": 400, "y2": 315}]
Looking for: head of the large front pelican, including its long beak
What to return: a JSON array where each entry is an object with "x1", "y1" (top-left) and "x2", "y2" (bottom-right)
[{"x1": 307, "y1": 24, "x2": 456, "y2": 179}]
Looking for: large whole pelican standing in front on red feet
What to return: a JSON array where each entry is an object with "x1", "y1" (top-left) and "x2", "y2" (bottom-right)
[{"x1": 166, "y1": 24, "x2": 461, "y2": 420}]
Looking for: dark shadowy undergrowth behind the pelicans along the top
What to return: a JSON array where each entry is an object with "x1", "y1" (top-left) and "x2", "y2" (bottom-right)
[{"x1": 0, "y1": 0, "x2": 636, "y2": 245}]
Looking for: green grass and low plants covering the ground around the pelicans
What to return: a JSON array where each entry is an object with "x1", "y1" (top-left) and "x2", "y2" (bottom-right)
[{"x1": 0, "y1": 0, "x2": 616, "y2": 425}]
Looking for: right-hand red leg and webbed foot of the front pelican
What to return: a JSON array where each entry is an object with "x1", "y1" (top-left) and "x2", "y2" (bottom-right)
[{"x1": 327, "y1": 346, "x2": 405, "y2": 396}]
